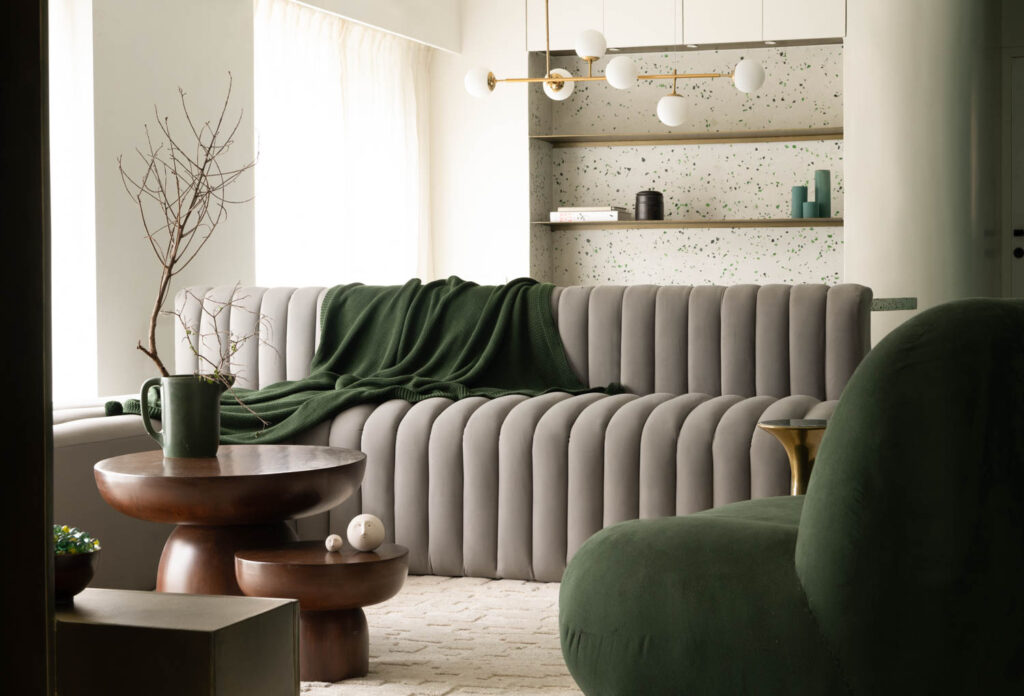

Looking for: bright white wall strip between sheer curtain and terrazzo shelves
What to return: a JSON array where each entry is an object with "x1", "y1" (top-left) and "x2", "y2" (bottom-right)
[{"x1": 430, "y1": 0, "x2": 529, "y2": 282}]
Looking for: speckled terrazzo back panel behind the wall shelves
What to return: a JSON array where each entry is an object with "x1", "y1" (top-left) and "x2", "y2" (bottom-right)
[{"x1": 530, "y1": 45, "x2": 844, "y2": 285}]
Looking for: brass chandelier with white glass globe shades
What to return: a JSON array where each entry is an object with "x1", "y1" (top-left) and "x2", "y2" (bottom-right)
[{"x1": 465, "y1": 0, "x2": 765, "y2": 127}]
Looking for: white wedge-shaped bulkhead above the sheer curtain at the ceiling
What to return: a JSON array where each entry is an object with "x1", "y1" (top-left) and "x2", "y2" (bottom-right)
[{"x1": 302, "y1": 0, "x2": 460, "y2": 52}]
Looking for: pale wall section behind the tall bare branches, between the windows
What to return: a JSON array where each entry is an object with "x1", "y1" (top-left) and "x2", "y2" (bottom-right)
[{"x1": 93, "y1": 0, "x2": 254, "y2": 394}]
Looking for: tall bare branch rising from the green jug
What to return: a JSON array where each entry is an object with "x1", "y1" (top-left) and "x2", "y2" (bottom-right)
[{"x1": 118, "y1": 73, "x2": 256, "y2": 377}]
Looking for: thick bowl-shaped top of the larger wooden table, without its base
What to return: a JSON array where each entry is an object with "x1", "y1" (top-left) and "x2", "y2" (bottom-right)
[{"x1": 94, "y1": 444, "x2": 367, "y2": 525}]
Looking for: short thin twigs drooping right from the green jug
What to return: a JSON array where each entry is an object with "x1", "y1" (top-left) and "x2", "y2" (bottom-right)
[{"x1": 169, "y1": 284, "x2": 278, "y2": 427}]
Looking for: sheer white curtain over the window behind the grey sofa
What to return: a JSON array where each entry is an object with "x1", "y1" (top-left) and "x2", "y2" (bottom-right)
[{"x1": 253, "y1": 0, "x2": 433, "y2": 286}]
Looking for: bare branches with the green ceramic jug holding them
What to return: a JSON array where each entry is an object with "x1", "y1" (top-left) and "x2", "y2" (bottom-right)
[{"x1": 118, "y1": 74, "x2": 255, "y2": 458}]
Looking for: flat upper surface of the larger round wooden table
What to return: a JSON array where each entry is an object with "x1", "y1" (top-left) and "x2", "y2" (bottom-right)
[{"x1": 96, "y1": 444, "x2": 367, "y2": 478}]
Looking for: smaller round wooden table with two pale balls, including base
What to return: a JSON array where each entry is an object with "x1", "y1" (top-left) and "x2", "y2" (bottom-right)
[{"x1": 234, "y1": 541, "x2": 409, "y2": 682}]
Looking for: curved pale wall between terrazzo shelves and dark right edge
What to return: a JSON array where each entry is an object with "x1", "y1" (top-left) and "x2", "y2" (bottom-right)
[{"x1": 844, "y1": 0, "x2": 999, "y2": 341}]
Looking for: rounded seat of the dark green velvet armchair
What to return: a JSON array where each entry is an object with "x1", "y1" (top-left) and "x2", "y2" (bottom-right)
[{"x1": 559, "y1": 496, "x2": 848, "y2": 696}]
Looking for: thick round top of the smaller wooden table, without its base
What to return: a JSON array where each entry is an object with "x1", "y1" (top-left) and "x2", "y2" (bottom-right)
[{"x1": 234, "y1": 541, "x2": 409, "y2": 611}]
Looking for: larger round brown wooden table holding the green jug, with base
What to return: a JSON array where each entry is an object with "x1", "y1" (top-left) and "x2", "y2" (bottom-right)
[{"x1": 94, "y1": 444, "x2": 367, "y2": 595}]
